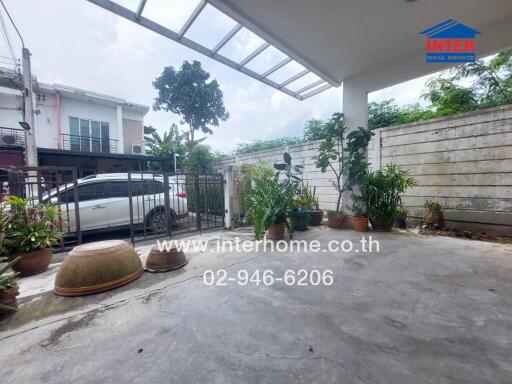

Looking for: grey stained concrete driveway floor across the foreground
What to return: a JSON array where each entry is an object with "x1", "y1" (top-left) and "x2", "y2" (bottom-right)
[{"x1": 0, "y1": 227, "x2": 512, "y2": 384}]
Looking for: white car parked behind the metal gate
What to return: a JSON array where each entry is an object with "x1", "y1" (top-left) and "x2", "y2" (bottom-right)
[{"x1": 41, "y1": 173, "x2": 188, "y2": 231}]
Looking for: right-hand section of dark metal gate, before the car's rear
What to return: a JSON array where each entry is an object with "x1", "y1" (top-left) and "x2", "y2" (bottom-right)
[{"x1": 128, "y1": 172, "x2": 225, "y2": 243}]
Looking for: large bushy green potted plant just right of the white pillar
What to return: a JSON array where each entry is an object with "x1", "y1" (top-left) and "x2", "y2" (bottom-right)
[{"x1": 360, "y1": 164, "x2": 416, "y2": 232}]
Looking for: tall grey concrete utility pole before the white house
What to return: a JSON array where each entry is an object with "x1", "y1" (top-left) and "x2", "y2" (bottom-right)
[{"x1": 21, "y1": 48, "x2": 37, "y2": 167}]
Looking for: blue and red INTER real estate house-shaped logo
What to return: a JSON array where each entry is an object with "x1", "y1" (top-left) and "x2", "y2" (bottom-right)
[{"x1": 420, "y1": 19, "x2": 480, "y2": 63}]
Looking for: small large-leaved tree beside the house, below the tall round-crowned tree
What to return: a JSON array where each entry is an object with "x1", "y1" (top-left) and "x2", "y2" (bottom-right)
[{"x1": 145, "y1": 123, "x2": 186, "y2": 171}]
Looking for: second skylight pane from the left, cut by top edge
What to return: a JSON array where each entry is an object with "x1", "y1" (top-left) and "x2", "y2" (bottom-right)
[{"x1": 142, "y1": 0, "x2": 204, "y2": 32}]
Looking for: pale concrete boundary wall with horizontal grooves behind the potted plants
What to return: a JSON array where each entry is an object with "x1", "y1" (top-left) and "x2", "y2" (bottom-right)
[{"x1": 221, "y1": 105, "x2": 512, "y2": 235}]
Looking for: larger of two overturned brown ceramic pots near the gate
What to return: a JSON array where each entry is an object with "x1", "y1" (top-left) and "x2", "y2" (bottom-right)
[{"x1": 53, "y1": 240, "x2": 144, "y2": 296}]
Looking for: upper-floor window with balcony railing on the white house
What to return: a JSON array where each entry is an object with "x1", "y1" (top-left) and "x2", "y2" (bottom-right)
[{"x1": 64, "y1": 117, "x2": 109, "y2": 153}]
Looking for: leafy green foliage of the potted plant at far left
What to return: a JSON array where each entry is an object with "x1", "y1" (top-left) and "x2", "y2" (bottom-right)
[{"x1": 2, "y1": 196, "x2": 62, "y2": 253}]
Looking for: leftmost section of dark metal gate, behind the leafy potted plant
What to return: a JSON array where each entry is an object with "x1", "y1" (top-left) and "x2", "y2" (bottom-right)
[{"x1": 0, "y1": 166, "x2": 82, "y2": 251}]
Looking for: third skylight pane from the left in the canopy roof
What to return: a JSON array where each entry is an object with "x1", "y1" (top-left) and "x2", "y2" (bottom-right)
[{"x1": 185, "y1": 4, "x2": 237, "y2": 49}]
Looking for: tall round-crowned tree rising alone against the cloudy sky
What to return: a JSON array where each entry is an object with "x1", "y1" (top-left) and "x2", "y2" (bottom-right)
[{"x1": 153, "y1": 61, "x2": 229, "y2": 146}]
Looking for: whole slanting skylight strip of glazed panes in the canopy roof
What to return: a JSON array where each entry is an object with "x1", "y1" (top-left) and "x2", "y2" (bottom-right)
[{"x1": 88, "y1": 0, "x2": 332, "y2": 100}]
